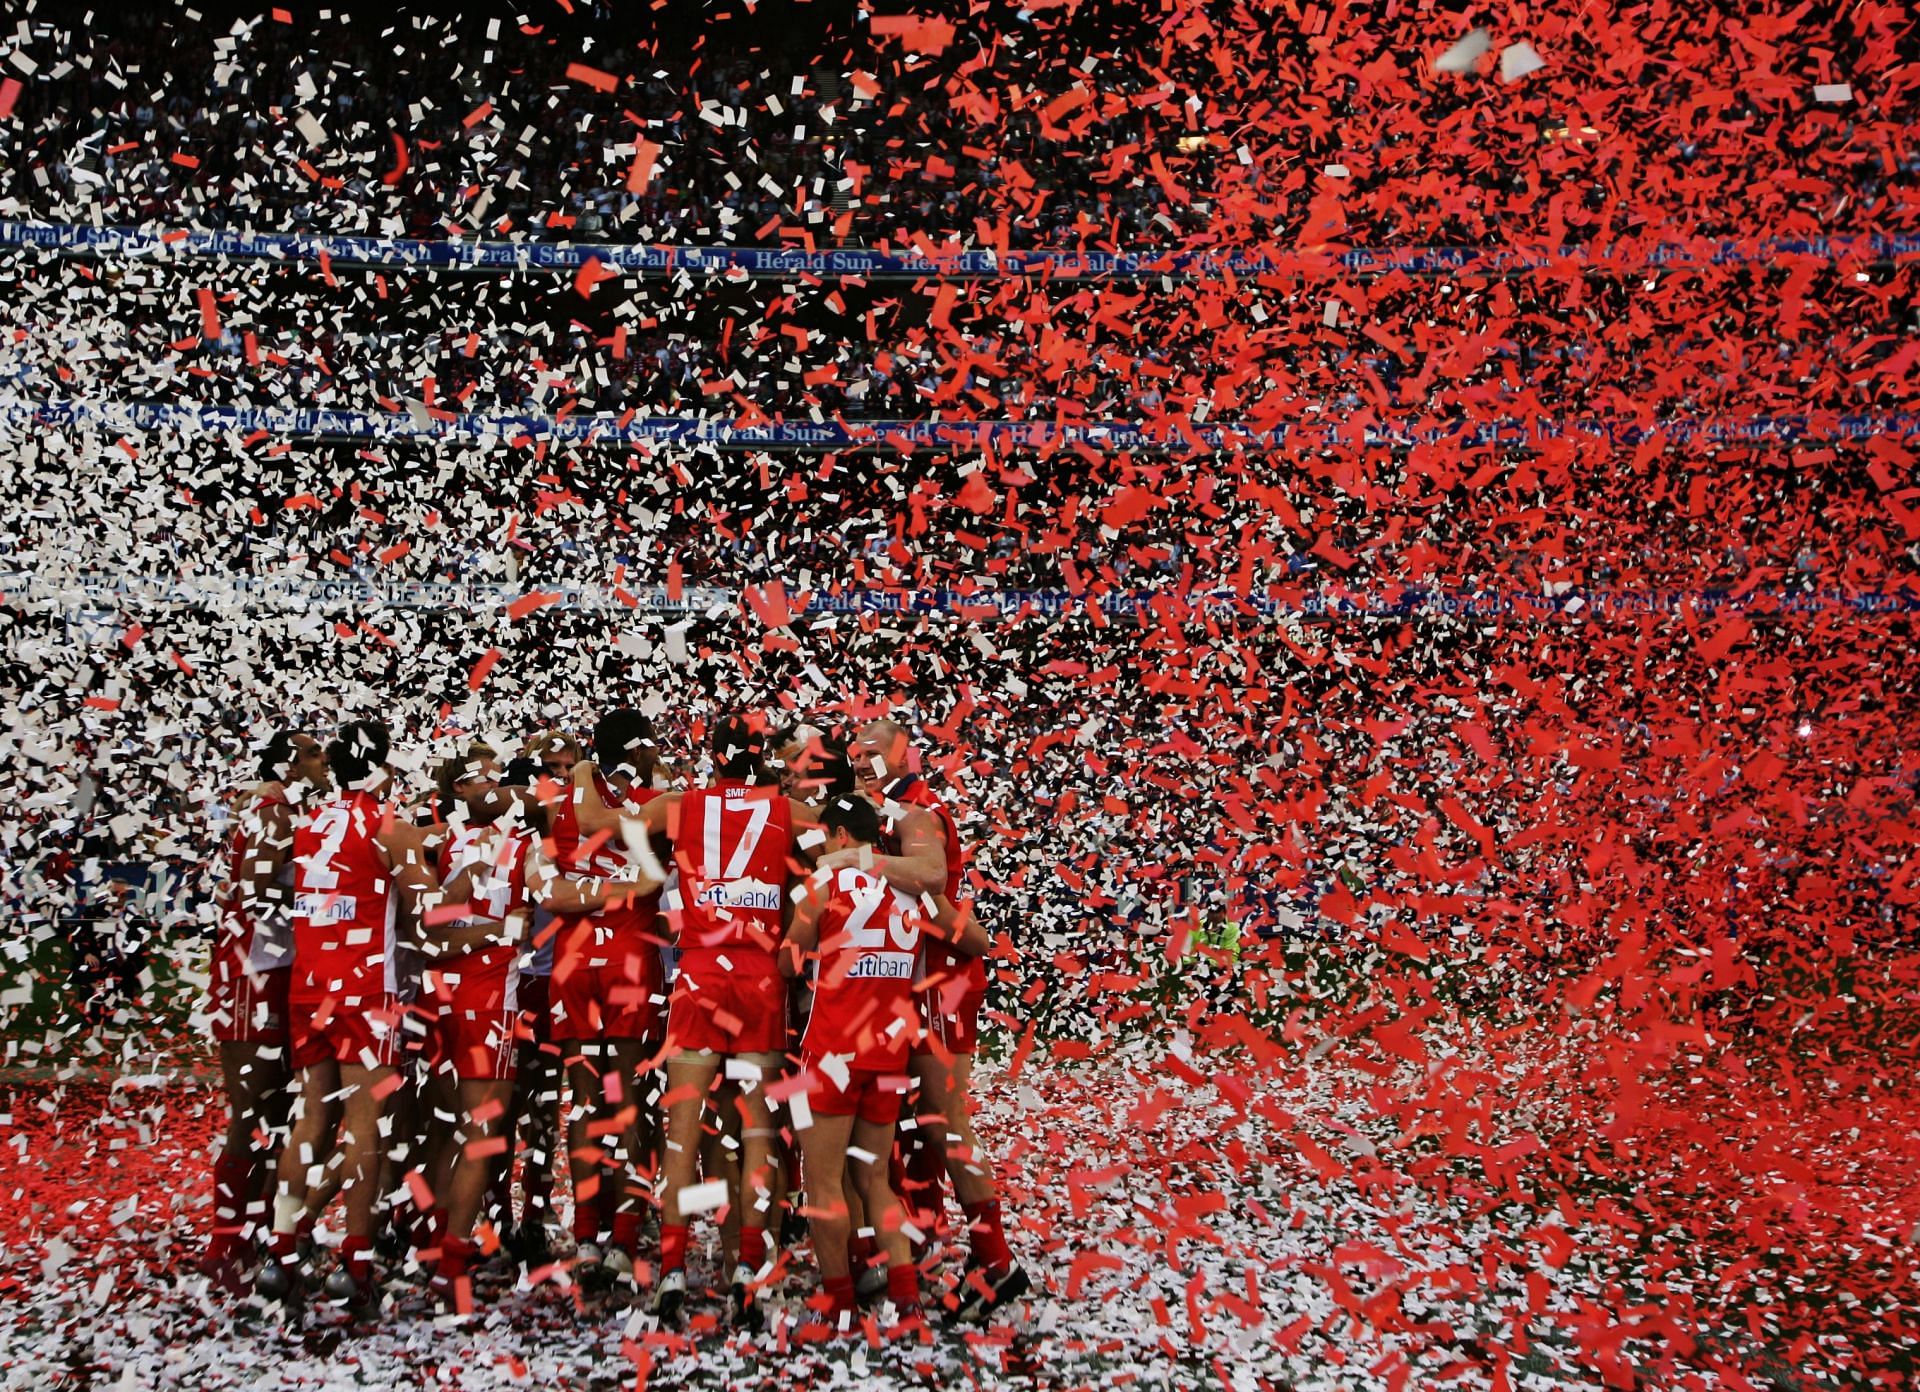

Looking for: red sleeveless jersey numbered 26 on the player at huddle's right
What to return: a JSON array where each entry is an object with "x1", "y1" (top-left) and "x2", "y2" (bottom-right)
[{"x1": 803, "y1": 866, "x2": 920, "y2": 1071}]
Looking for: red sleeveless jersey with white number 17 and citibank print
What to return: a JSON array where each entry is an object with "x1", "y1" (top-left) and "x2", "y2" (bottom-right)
[{"x1": 668, "y1": 778, "x2": 793, "y2": 952}]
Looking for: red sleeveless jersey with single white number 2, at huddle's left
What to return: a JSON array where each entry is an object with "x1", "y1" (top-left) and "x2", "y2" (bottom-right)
[{"x1": 294, "y1": 793, "x2": 399, "y2": 1000}]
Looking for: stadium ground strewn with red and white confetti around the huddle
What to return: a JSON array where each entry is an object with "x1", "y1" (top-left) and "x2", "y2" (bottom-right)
[{"x1": 0, "y1": 960, "x2": 1920, "y2": 1388}]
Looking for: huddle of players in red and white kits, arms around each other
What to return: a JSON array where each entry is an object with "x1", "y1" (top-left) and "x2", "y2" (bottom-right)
[{"x1": 202, "y1": 708, "x2": 1027, "y2": 1336}]
